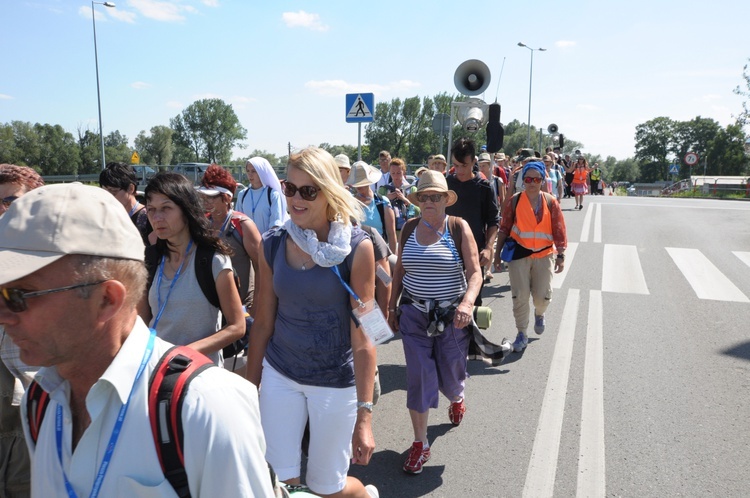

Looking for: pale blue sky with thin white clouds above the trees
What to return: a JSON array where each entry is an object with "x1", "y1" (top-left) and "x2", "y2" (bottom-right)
[{"x1": 0, "y1": 0, "x2": 750, "y2": 159}]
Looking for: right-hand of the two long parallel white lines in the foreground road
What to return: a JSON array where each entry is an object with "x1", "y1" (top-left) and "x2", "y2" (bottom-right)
[{"x1": 576, "y1": 290, "x2": 606, "y2": 497}]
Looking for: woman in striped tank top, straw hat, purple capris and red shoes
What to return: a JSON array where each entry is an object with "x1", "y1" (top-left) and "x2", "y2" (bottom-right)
[{"x1": 388, "y1": 171, "x2": 482, "y2": 474}]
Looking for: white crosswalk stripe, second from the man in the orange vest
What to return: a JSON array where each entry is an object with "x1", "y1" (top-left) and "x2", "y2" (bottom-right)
[{"x1": 602, "y1": 244, "x2": 649, "y2": 294}]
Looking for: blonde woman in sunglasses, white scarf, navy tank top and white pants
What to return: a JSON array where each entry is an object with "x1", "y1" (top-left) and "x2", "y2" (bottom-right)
[{"x1": 247, "y1": 147, "x2": 377, "y2": 498}]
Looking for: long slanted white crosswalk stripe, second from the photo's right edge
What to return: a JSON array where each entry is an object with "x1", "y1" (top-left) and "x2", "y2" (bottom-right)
[{"x1": 666, "y1": 247, "x2": 750, "y2": 303}]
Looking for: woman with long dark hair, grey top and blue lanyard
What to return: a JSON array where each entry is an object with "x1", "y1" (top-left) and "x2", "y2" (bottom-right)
[{"x1": 139, "y1": 172, "x2": 245, "y2": 365}]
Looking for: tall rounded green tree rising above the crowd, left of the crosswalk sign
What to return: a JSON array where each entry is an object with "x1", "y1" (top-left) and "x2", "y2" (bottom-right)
[{"x1": 170, "y1": 99, "x2": 247, "y2": 164}]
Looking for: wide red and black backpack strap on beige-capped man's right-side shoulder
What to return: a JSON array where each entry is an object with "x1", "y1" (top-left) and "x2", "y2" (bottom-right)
[{"x1": 148, "y1": 346, "x2": 214, "y2": 498}]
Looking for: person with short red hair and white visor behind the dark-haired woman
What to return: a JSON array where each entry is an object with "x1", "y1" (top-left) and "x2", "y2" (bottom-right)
[{"x1": 198, "y1": 164, "x2": 260, "y2": 317}]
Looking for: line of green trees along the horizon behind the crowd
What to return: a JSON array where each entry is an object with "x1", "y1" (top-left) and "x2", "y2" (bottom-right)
[{"x1": 0, "y1": 61, "x2": 750, "y2": 182}]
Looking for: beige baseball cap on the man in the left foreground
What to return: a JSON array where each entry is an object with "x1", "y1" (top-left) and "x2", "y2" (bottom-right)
[{"x1": 0, "y1": 183, "x2": 145, "y2": 284}]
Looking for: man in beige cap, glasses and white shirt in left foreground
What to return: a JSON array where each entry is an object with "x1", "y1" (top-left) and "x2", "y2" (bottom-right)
[{"x1": 0, "y1": 183, "x2": 273, "y2": 497}]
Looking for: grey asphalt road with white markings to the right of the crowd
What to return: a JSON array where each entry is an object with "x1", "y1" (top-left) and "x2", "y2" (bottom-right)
[{"x1": 351, "y1": 196, "x2": 750, "y2": 497}]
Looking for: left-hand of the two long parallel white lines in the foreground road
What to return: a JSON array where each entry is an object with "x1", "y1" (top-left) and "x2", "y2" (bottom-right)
[{"x1": 523, "y1": 289, "x2": 580, "y2": 498}]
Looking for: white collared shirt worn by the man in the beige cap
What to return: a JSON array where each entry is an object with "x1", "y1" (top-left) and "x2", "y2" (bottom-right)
[{"x1": 21, "y1": 318, "x2": 274, "y2": 498}]
